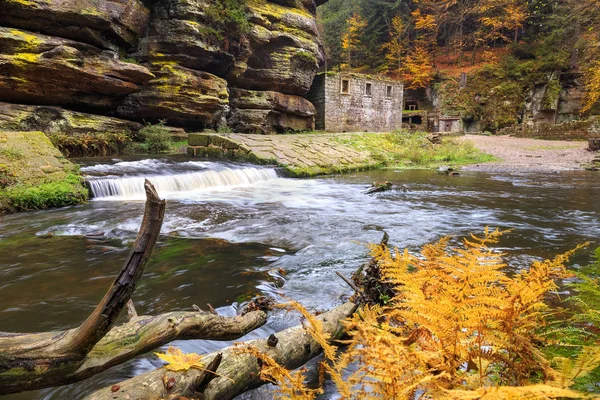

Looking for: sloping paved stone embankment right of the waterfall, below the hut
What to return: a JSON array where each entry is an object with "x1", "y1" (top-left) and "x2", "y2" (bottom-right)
[{"x1": 188, "y1": 133, "x2": 381, "y2": 177}]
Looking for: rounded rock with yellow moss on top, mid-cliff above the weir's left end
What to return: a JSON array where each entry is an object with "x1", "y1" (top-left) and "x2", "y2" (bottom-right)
[{"x1": 117, "y1": 62, "x2": 229, "y2": 129}]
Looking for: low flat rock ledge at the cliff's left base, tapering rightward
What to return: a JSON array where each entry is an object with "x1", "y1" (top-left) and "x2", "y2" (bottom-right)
[{"x1": 0, "y1": 102, "x2": 142, "y2": 135}]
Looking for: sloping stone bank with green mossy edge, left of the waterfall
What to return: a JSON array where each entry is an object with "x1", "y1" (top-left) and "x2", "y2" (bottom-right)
[{"x1": 0, "y1": 132, "x2": 88, "y2": 215}]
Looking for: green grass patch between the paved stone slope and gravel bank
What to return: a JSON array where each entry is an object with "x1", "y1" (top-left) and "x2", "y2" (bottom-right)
[{"x1": 336, "y1": 130, "x2": 494, "y2": 168}]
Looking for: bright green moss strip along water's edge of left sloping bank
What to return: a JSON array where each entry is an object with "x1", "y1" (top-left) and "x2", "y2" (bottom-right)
[{"x1": 0, "y1": 173, "x2": 88, "y2": 213}]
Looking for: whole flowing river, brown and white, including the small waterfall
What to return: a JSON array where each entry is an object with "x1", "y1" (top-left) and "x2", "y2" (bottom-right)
[{"x1": 0, "y1": 159, "x2": 600, "y2": 400}]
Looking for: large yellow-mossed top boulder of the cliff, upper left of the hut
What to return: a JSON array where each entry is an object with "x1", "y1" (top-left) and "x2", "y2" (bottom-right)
[{"x1": 227, "y1": 0, "x2": 324, "y2": 96}]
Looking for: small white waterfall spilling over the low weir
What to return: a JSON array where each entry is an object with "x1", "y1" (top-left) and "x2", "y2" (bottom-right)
[{"x1": 88, "y1": 163, "x2": 277, "y2": 200}]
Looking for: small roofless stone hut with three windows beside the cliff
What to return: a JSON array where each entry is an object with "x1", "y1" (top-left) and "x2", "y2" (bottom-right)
[{"x1": 306, "y1": 72, "x2": 404, "y2": 132}]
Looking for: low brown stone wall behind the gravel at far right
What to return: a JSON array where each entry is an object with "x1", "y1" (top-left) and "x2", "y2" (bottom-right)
[{"x1": 499, "y1": 118, "x2": 600, "y2": 140}]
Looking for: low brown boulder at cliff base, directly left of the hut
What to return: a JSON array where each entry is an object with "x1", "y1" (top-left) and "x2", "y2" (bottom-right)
[{"x1": 228, "y1": 89, "x2": 316, "y2": 134}]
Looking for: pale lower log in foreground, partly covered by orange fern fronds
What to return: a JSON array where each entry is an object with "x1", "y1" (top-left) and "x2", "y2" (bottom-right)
[{"x1": 86, "y1": 303, "x2": 356, "y2": 400}]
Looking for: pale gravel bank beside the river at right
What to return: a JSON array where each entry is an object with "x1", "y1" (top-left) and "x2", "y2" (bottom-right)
[{"x1": 459, "y1": 135, "x2": 595, "y2": 172}]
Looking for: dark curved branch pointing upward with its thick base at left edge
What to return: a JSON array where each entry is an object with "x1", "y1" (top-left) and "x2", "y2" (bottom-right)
[{"x1": 0, "y1": 181, "x2": 165, "y2": 394}]
